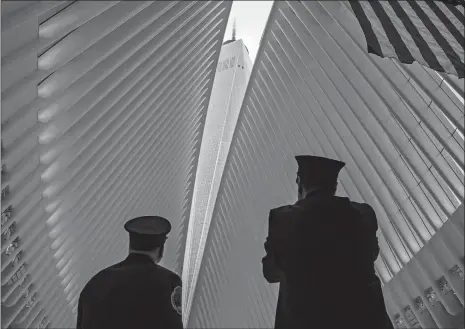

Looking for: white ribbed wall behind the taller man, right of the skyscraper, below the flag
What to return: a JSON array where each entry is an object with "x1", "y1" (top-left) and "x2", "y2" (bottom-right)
[{"x1": 189, "y1": 1, "x2": 464, "y2": 328}]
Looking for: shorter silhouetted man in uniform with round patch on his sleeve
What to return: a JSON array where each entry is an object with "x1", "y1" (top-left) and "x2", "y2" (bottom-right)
[{"x1": 77, "y1": 216, "x2": 183, "y2": 329}]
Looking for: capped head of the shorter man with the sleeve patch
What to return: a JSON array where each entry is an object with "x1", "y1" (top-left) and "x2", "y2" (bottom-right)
[{"x1": 124, "y1": 216, "x2": 171, "y2": 263}]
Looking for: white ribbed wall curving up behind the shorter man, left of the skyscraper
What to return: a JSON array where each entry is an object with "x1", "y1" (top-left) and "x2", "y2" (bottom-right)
[{"x1": 1, "y1": 1, "x2": 231, "y2": 328}]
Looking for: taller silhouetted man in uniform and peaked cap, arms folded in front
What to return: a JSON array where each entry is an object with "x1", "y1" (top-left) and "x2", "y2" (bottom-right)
[{"x1": 262, "y1": 156, "x2": 393, "y2": 329}]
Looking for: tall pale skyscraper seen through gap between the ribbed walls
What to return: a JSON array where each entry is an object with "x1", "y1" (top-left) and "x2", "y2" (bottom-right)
[{"x1": 183, "y1": 40, "x2": 252, "y2": 323}]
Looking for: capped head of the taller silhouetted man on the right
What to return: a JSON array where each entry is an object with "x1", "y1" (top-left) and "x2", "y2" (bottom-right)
[{"x1": 295, "y1": 155, "x2": 345, "y2": 200}]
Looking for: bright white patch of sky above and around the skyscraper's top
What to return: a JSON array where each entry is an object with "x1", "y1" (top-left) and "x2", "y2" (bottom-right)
[{"x1": 224, "y1": 0, "x2": 273, "y2": 62}]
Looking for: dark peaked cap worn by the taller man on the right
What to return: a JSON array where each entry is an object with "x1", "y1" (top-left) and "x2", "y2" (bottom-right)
[{"x1": 295, "y1": 155, "x2": 345, "y2": 185}]
